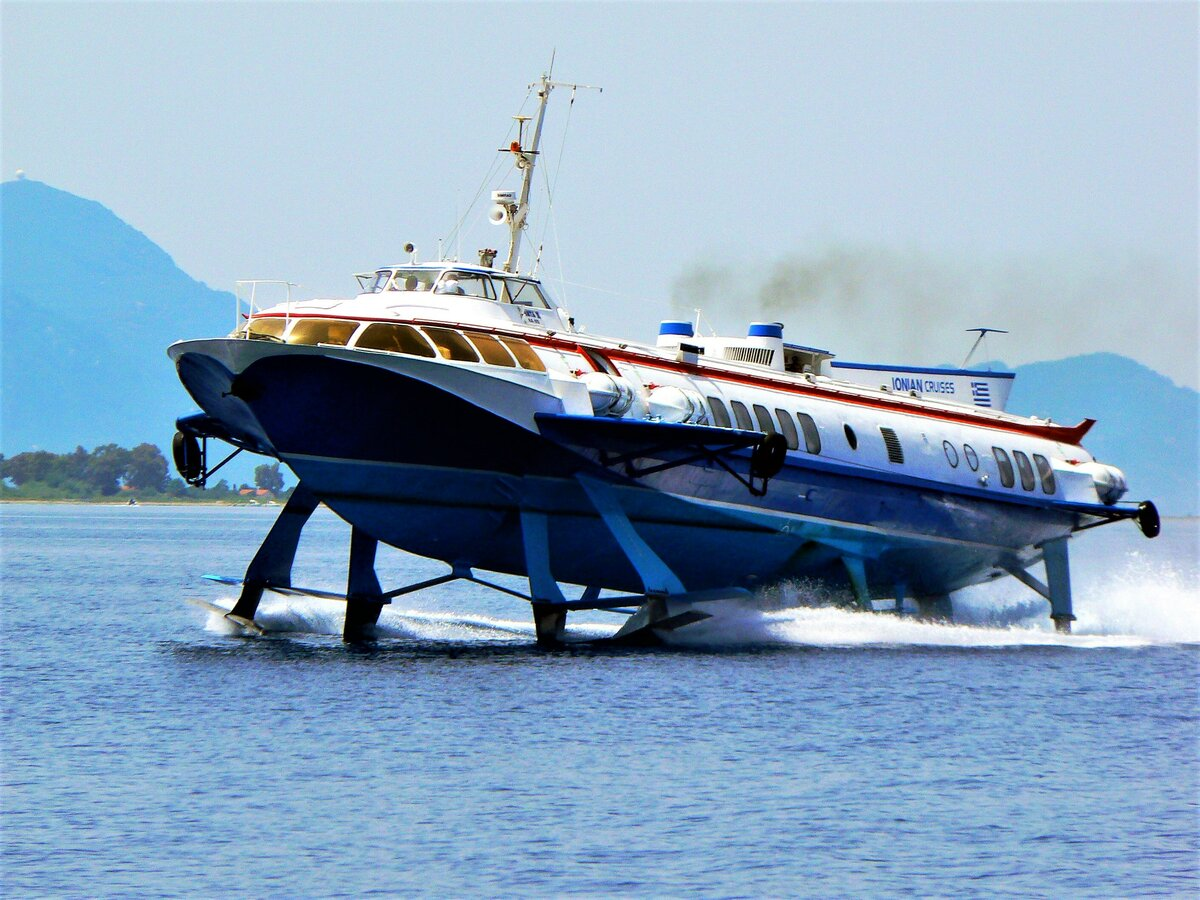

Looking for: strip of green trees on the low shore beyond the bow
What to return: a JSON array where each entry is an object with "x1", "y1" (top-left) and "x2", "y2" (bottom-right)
[{"x1": 0, "y1": 444, "x2": 288, "y2": 503}]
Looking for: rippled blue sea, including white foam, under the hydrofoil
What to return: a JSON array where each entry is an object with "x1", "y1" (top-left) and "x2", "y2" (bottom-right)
[{"x1": 0, "y1": 504, "x2": 1200, "y2": 898}]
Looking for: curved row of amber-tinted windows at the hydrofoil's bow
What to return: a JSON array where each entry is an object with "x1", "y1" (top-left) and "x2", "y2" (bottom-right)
[{"x1": 246, "y1": 318, "x2": 546, "y2": 372}]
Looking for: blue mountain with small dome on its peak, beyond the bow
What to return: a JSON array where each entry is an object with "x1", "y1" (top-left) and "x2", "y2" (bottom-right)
[{"x1": 0, "y1": 180, "x2": 233, "y2": 456}]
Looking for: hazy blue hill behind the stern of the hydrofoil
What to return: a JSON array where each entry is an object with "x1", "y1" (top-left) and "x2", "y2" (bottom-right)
[{"x1": 1008, "y1": 353, "x2": 1200, "y2": 516}]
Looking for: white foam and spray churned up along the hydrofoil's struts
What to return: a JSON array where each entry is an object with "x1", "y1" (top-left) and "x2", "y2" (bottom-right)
[{"x1": 199, "y1": 553, "x2": 1200, "y2": 648}]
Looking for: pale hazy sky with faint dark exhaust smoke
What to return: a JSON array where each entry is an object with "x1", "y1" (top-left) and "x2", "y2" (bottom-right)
[{"x1": 0, "y1": 0, "x2": 1200, "y2": 388}]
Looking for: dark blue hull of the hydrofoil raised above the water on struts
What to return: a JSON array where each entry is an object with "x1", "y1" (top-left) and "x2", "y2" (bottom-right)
[{"x1": 173, "y1": 341, "x2": 1078, "y2": 596}]
